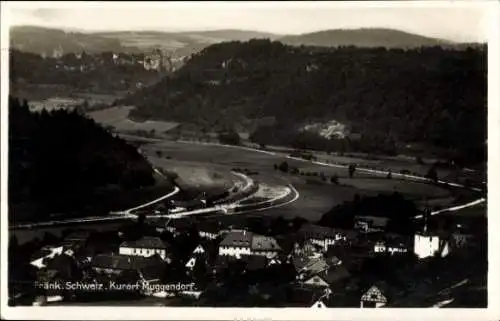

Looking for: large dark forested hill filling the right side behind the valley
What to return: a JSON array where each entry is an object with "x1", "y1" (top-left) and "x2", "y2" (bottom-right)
[{"x1": 123, "y1": 40, "x2": 487, "y2": 163}]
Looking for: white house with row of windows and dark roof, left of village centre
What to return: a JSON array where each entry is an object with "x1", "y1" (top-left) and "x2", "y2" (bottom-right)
[{"x1": 119, "y1": 236, "x2": 170, "y2": 260}]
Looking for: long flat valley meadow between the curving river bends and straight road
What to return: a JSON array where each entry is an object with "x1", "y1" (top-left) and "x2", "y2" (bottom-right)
[{"x1": 142, "y1": 141, "x2": 460, "y2": 220}]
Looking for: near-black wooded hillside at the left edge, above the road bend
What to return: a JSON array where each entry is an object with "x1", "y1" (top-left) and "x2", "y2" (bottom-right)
[{"x1": 9, "y1": 97, "x2": 159, "y2": 221}]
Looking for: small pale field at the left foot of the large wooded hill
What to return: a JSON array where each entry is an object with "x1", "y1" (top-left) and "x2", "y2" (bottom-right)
[{"x1": 89, "y1": 106, "x2": 178, "y2": 133}]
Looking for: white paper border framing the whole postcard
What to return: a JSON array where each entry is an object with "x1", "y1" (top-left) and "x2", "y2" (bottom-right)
[{"x1": 0, "y1": 1, "x2": 500, "y2": 320}]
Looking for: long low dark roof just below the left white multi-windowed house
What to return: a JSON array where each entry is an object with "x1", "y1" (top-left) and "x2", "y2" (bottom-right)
[{"x1": 91, "y1": 254, "x2": 163, "y2": 270}]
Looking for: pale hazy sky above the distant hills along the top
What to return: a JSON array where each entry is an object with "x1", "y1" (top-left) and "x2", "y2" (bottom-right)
[{"x1": 4, "y1": 1, "x2": 488, "y2": 42}]
